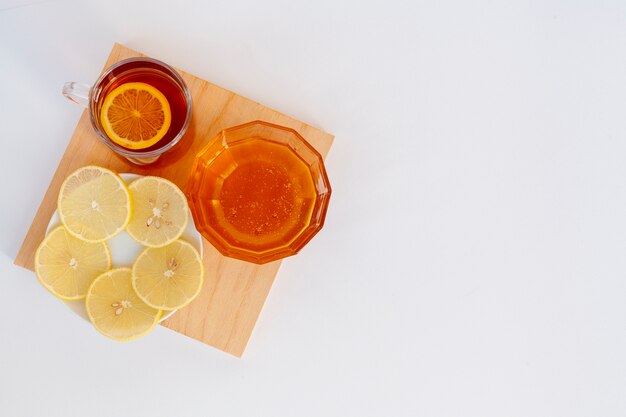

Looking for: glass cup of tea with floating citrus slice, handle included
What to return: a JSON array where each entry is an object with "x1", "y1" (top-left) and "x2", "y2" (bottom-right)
[{"x1": 63, "y1": 58, "x2": 191, "y2": 164}]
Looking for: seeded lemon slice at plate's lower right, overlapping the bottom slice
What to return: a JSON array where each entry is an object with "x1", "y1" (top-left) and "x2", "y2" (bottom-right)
[{"x1": 133, "y1": 240, "x2": 204, "y2": 310}]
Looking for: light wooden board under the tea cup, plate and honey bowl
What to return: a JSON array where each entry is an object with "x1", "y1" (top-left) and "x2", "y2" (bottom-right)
[{"x1": 15, "y1": 44, "x2": 334, "y2": 357}]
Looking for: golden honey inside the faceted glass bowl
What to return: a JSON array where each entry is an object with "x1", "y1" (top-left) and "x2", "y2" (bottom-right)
[{"x1": 198, "y1": 138, "x2": 316, "y2": 250}]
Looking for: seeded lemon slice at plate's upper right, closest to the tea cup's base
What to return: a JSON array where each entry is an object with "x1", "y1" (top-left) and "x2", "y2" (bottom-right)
[{"x1": 126, "y1": 177, "x2": 189, "y2": 247}]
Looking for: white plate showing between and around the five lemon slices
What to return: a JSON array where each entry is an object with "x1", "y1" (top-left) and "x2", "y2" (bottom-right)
[{"x1": 46, "y1": 174, "x2": 202, "y2": 322}]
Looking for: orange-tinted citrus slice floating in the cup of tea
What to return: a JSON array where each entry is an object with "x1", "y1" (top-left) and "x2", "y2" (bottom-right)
[{"x1": 100, "y1": 82, "x2": 172, "y2": 149}]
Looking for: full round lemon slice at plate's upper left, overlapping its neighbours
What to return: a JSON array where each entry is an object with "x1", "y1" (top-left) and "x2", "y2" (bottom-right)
[{"x1": 58, "y1": 166, "x2": 131, "y2": 242}]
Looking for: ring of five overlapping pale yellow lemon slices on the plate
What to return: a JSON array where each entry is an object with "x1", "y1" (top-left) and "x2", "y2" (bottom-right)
[{"x1": 35, "y1": 166, "x2": 204, "y2": 341}]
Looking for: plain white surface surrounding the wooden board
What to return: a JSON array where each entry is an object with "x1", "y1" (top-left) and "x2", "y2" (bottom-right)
[{"x1": 0, "y1": 0, "x2": 626, "y2": 417}]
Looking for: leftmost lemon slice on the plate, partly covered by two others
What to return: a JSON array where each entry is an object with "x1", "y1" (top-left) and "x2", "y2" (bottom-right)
[{"x1": 35, "y1": 226, "x2": 111, "y2": 300}]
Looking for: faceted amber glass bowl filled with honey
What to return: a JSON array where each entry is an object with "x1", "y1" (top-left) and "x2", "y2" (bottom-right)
[{"x1": 185, "y1": 121, "x2": 331, "y2": 264}]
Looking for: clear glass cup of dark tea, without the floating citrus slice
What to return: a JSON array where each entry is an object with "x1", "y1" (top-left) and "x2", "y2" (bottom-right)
[{"x1": 63, "y1": 57, "x2": 192, "y2": 165}]
